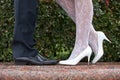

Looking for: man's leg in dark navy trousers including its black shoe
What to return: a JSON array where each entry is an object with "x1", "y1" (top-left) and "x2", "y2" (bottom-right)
[{"x1": 12, "y1": 0, "x2": 58, "y2": 65}]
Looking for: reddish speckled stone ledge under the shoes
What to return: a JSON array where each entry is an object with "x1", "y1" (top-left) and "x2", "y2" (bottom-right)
[{"x1": 0, "y1": 62, "x2": 120, "y2": 80}]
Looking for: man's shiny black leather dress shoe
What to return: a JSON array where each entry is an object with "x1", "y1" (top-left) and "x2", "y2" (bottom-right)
[{"x1": 15, "y1": 55, "x2": 58, "y2": 65}]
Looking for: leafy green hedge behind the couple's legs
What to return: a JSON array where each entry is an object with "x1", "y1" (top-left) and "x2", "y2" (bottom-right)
[{"x1": 0, "y1": 0, "x2": 120, "y2": 61}]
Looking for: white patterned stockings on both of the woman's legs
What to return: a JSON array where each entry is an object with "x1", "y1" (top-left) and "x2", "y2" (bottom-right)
[{"x1": 56, "y1": 0, "x2": 98, "y2": 59}]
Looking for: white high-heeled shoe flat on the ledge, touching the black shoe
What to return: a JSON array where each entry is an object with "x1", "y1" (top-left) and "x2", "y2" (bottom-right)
[{"x1": 59, "y1": 46, "x2": 92, "y2": 65}]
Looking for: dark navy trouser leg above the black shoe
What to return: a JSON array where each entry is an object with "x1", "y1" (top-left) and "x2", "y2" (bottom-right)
[{"x1": 12, "y1": 0, "x2": 38, "y2": 58}]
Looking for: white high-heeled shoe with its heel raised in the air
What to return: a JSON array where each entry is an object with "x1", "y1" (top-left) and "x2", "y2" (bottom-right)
[{"x1": 92, "y1": 31, "x2": 111, "y2": 64}]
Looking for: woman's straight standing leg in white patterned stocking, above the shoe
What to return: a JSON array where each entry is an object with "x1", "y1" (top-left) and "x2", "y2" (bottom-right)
[{"x1": 69, "y1": 0, "x2": 93, "y2": 59}]
